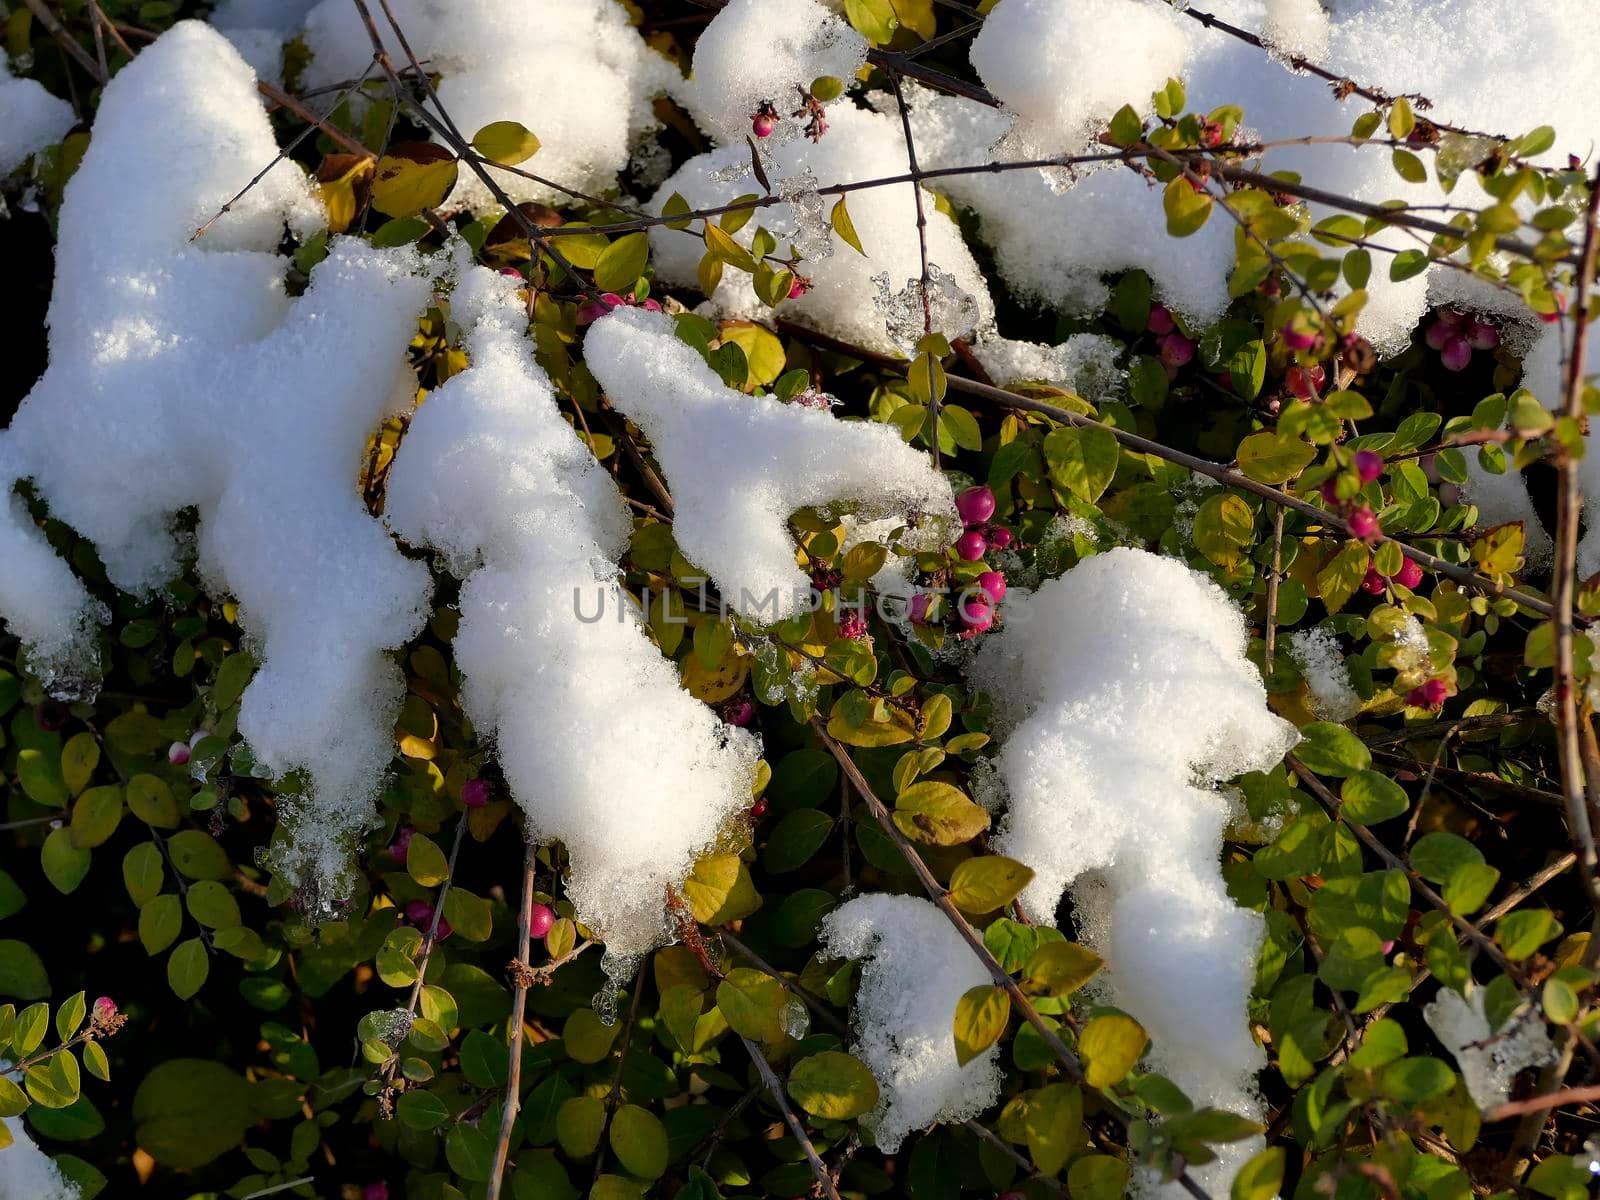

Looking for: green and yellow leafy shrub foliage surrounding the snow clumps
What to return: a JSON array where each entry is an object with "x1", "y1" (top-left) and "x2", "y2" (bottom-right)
[{"x1": 0, "y1": 0, "x2": 1600, "y2": 1200}]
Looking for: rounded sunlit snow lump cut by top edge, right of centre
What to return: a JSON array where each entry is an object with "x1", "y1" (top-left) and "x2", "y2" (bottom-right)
[{"x1": 970, "y1": 0, "x2": 1187, "y2": 155}]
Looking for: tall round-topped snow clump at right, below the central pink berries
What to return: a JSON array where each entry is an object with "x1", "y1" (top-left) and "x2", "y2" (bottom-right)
[{"x1": 971, "y1": 549, "x2": 1296, "y2": 1187}]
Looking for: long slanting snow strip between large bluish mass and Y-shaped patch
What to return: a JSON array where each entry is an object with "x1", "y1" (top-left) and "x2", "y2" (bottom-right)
[{"x1": 387, "y1": 267, "x2": 760, "y2": 974}]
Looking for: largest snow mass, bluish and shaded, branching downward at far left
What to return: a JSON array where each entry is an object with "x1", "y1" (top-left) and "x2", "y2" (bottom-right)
[{"x1": 0, "y1": 21, "x2": 429, "y2": 885}]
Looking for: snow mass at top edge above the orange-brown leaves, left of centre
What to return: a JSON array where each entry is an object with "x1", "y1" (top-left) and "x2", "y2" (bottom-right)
[{"x1": 306, "y1": 0, "x2": 682, "y2": 210}]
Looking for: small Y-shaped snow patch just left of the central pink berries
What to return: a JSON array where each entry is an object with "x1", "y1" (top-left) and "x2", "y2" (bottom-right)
[{"x1": 584, "y1": 307, "x2": 957, "y2": 621}]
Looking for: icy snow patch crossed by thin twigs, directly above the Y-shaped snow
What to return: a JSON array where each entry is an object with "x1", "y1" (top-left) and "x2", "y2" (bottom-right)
[{"x1": 650, "y1": 104, "x2": 994, "y2": 354}]
